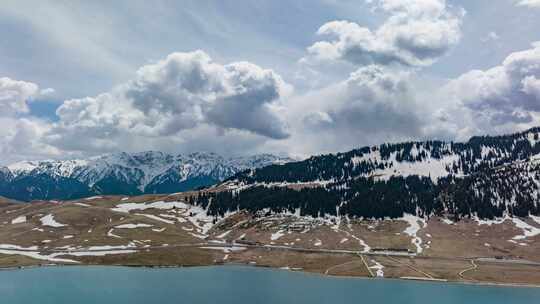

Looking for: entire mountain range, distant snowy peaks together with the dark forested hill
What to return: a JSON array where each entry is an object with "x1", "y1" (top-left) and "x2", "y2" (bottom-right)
[{"x1": 0, "y1": 128, "x2": 540, "y2": 219}]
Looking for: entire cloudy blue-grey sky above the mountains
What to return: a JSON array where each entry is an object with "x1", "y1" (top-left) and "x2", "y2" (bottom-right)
[{"x1": 0, "y1": 0, "x2": 540, "y2": 164}]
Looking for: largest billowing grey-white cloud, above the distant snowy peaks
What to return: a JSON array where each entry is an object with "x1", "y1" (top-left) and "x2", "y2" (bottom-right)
[{"x1": 47, "y1": 51, "x2": 292, "y2": 151}]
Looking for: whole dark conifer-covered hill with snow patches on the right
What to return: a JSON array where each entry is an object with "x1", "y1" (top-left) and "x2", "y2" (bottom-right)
[{"x1": 202, "y1": 128, "x2": 540, "y2": 218}]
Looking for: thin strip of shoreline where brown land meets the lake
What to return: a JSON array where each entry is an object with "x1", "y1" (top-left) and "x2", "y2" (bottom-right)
[{"x1": 0, "y1": 263, "x2": 540, "y2": 288}]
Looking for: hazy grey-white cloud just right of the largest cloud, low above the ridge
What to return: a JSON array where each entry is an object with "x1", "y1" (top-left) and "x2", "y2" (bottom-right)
[{"x1": 278, "y1": 65, "x2": 425, "y2": 155}]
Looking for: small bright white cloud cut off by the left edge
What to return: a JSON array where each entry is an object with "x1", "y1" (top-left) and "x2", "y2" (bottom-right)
[{"x1": 0, "y1": 77, "x2": 39, "y2": 116}]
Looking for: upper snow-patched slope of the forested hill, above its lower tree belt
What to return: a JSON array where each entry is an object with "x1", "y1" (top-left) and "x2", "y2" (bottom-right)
[{"x1": 231, "y1": 128, "x2": 540, "y2": 183}]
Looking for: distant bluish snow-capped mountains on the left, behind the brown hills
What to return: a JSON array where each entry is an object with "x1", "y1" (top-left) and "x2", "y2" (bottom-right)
[{"x1": 0, "y1": 151, "x2": 291, "y2": 200}]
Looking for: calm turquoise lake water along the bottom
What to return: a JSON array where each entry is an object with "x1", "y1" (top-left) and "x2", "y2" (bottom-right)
[{"x1": 0, "y1": 266, "x2": 540, "y2": 304}]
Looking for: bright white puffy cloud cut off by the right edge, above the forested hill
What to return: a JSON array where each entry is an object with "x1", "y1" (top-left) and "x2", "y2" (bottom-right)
[{"x1": 446, "y1": 42, "x2": 540, "y2": 125}]
